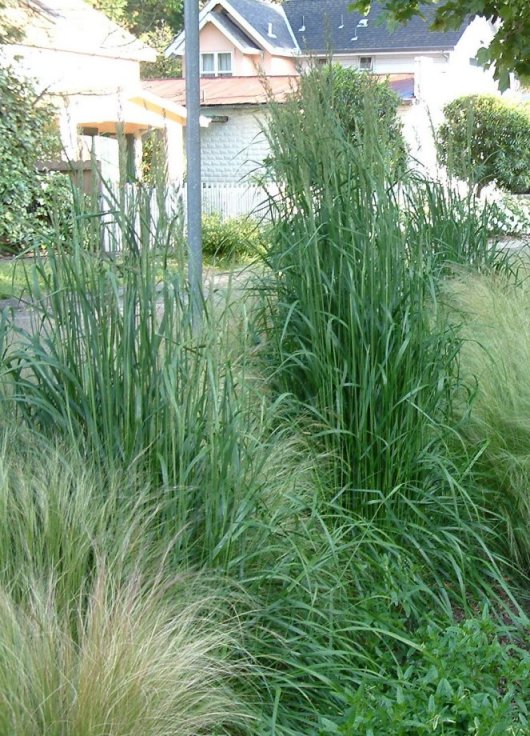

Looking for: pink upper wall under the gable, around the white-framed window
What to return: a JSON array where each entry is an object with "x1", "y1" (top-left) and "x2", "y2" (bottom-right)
[{"x1": 182, "y1": 23, "x2": 296, "y2": 77}]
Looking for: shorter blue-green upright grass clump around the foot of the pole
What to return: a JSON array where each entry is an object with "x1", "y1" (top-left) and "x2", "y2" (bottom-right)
[{"x1": 2, "y1": 194, "x2": 278, "y2": 561}]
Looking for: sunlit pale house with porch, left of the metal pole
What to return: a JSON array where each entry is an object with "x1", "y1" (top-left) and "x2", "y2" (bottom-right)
[{"x1": 2, "y1": 0, "x2": 202, "y2": 182}]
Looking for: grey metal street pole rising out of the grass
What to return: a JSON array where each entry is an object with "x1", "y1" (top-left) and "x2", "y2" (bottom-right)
[{"x1": 184, "y1": 0, "x2": 203, "y2": 331}]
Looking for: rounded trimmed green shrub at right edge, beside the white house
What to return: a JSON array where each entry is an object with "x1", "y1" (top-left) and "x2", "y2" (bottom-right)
[{"x1": 438, "y1": 95, "x2": 530, "y2": 193}]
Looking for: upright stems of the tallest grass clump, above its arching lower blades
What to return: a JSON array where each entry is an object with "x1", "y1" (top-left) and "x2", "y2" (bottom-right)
[{"x1": 258, "y1": 74, "x2": 498, "y2": 515}]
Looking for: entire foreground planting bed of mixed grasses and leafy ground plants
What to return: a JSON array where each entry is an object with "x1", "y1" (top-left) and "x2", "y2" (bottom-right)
[{"x1": 0, "y1": 66, "x2": 530, "y2": 736}]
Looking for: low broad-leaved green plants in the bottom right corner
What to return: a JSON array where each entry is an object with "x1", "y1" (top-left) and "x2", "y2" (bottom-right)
[{"x1": 321, "y1": 615, "x2": 530, "y2": 736}]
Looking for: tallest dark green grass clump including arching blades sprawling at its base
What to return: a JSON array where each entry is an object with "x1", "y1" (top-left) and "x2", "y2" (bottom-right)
[{"x1": 241, "y1": 77, "x2": 521, "y2": 734}]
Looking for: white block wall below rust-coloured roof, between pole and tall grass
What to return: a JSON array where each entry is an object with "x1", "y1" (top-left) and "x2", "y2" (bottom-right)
[{"x1": 201, "y1": 106, "x2": 269, "y2": 184}]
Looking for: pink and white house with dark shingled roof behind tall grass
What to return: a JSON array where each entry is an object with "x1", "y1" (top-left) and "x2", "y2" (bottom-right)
[{"x1": 156, "y1": 0, "x2": 497, "y2": 183}]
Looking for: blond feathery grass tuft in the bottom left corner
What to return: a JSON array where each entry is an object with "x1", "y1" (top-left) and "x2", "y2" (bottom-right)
[{"x1": 0, "y1": 565, "x2": 248, "y2": 736}]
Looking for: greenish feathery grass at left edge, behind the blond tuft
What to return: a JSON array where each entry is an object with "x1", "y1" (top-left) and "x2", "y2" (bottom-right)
[{"x1": 0, "y1": 420, "x2": 157, "y2": 613}]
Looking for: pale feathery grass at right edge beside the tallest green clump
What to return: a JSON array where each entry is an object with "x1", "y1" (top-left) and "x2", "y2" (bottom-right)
[{"x1": 445, "y1": 263, "x2": 530, "y2": 569}]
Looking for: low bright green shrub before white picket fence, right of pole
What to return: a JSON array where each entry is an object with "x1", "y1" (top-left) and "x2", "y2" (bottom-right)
[{"x1": 202, "y1": 214, "x2": 265, "y2": 261}]
